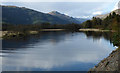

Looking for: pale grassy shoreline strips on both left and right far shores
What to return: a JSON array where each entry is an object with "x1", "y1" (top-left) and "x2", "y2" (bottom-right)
[{"x1": 0, "y1": 29, "x2": 112, "y2": 39}]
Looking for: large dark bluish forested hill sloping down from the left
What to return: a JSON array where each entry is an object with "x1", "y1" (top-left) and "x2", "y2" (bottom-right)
[{"x1": 2, "y1": 6, "x2": 79, "y2": 24}]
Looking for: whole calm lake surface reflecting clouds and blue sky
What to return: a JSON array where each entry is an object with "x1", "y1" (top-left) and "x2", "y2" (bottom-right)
[{"x1": 0, "y1": 32, "x2": 115, "y2": 71}]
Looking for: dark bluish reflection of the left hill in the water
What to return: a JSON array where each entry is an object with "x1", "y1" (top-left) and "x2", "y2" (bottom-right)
[{"x1": 2, "y1": 32, "x2": 73, "y2": 50}]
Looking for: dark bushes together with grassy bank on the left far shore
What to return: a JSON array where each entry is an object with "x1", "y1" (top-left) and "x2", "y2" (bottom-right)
[{"x1": 2, "y1": 23, "x2": 81, "y2": 39}]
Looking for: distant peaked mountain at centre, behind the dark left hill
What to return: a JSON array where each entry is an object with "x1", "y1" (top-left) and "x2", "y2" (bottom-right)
[{"x1": 48, "y1": 11, "x2": 81, "y2": 23}]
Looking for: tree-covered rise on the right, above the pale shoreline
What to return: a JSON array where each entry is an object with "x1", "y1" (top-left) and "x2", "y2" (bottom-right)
[{"x1": 83, "y1": 12, "x2": 120, "y2": 30}]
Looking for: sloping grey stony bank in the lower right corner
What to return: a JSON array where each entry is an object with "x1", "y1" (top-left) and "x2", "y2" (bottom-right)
[{"x1": 88, "y1": 47, "x2": 120, "y2": 73}]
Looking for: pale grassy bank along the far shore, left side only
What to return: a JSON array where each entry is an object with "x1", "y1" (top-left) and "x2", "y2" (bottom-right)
[{"x1": 0, "y1": 29, "x2": 65, "y2": 39}]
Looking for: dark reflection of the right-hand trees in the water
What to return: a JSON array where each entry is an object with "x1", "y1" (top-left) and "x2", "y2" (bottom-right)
[{"x1": 84, "y1": 31, "x2": 120, "y2": 46}]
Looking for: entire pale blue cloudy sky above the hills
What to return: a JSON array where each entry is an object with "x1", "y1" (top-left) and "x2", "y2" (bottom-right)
[{"x1": 1, "y1": 0, "x2": 119, "y2": 18}]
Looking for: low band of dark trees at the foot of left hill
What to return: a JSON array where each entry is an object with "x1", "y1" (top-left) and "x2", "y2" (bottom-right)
[{"x1": 2, "y1": 23, "x2": 81, "y2": 32}]
